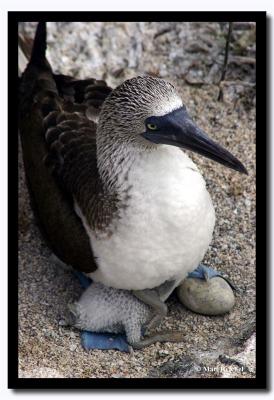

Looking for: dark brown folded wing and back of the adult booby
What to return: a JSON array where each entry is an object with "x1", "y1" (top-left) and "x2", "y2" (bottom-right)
[{"x1": 19, "y1": 36, "x2": 111, "y2": 272}]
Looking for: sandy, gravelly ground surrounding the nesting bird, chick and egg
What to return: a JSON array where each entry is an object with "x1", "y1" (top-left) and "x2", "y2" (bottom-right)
[{"x1": 18, "y1": 23, "x2": 255, "y2": 378}]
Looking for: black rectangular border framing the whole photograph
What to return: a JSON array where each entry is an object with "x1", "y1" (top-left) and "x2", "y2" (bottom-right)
[{"x1": 7, "y1": 11, "x2": 269, "y2": 390}]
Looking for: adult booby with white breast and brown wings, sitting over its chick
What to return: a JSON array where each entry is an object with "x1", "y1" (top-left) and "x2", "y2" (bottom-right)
[{"x1": 20, "y1": 23, "x2": 246, "y2": 346}]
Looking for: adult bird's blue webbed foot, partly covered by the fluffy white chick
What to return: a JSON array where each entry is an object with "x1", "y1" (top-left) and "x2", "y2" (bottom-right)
[{"x1": 73, "y1": 271, "x2": 130, "y2": 352}]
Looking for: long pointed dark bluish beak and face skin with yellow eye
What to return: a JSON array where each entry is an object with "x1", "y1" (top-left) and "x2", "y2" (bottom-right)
[{"x1": 142, "y1": 107, "x2": 248, "y2": 174}]
